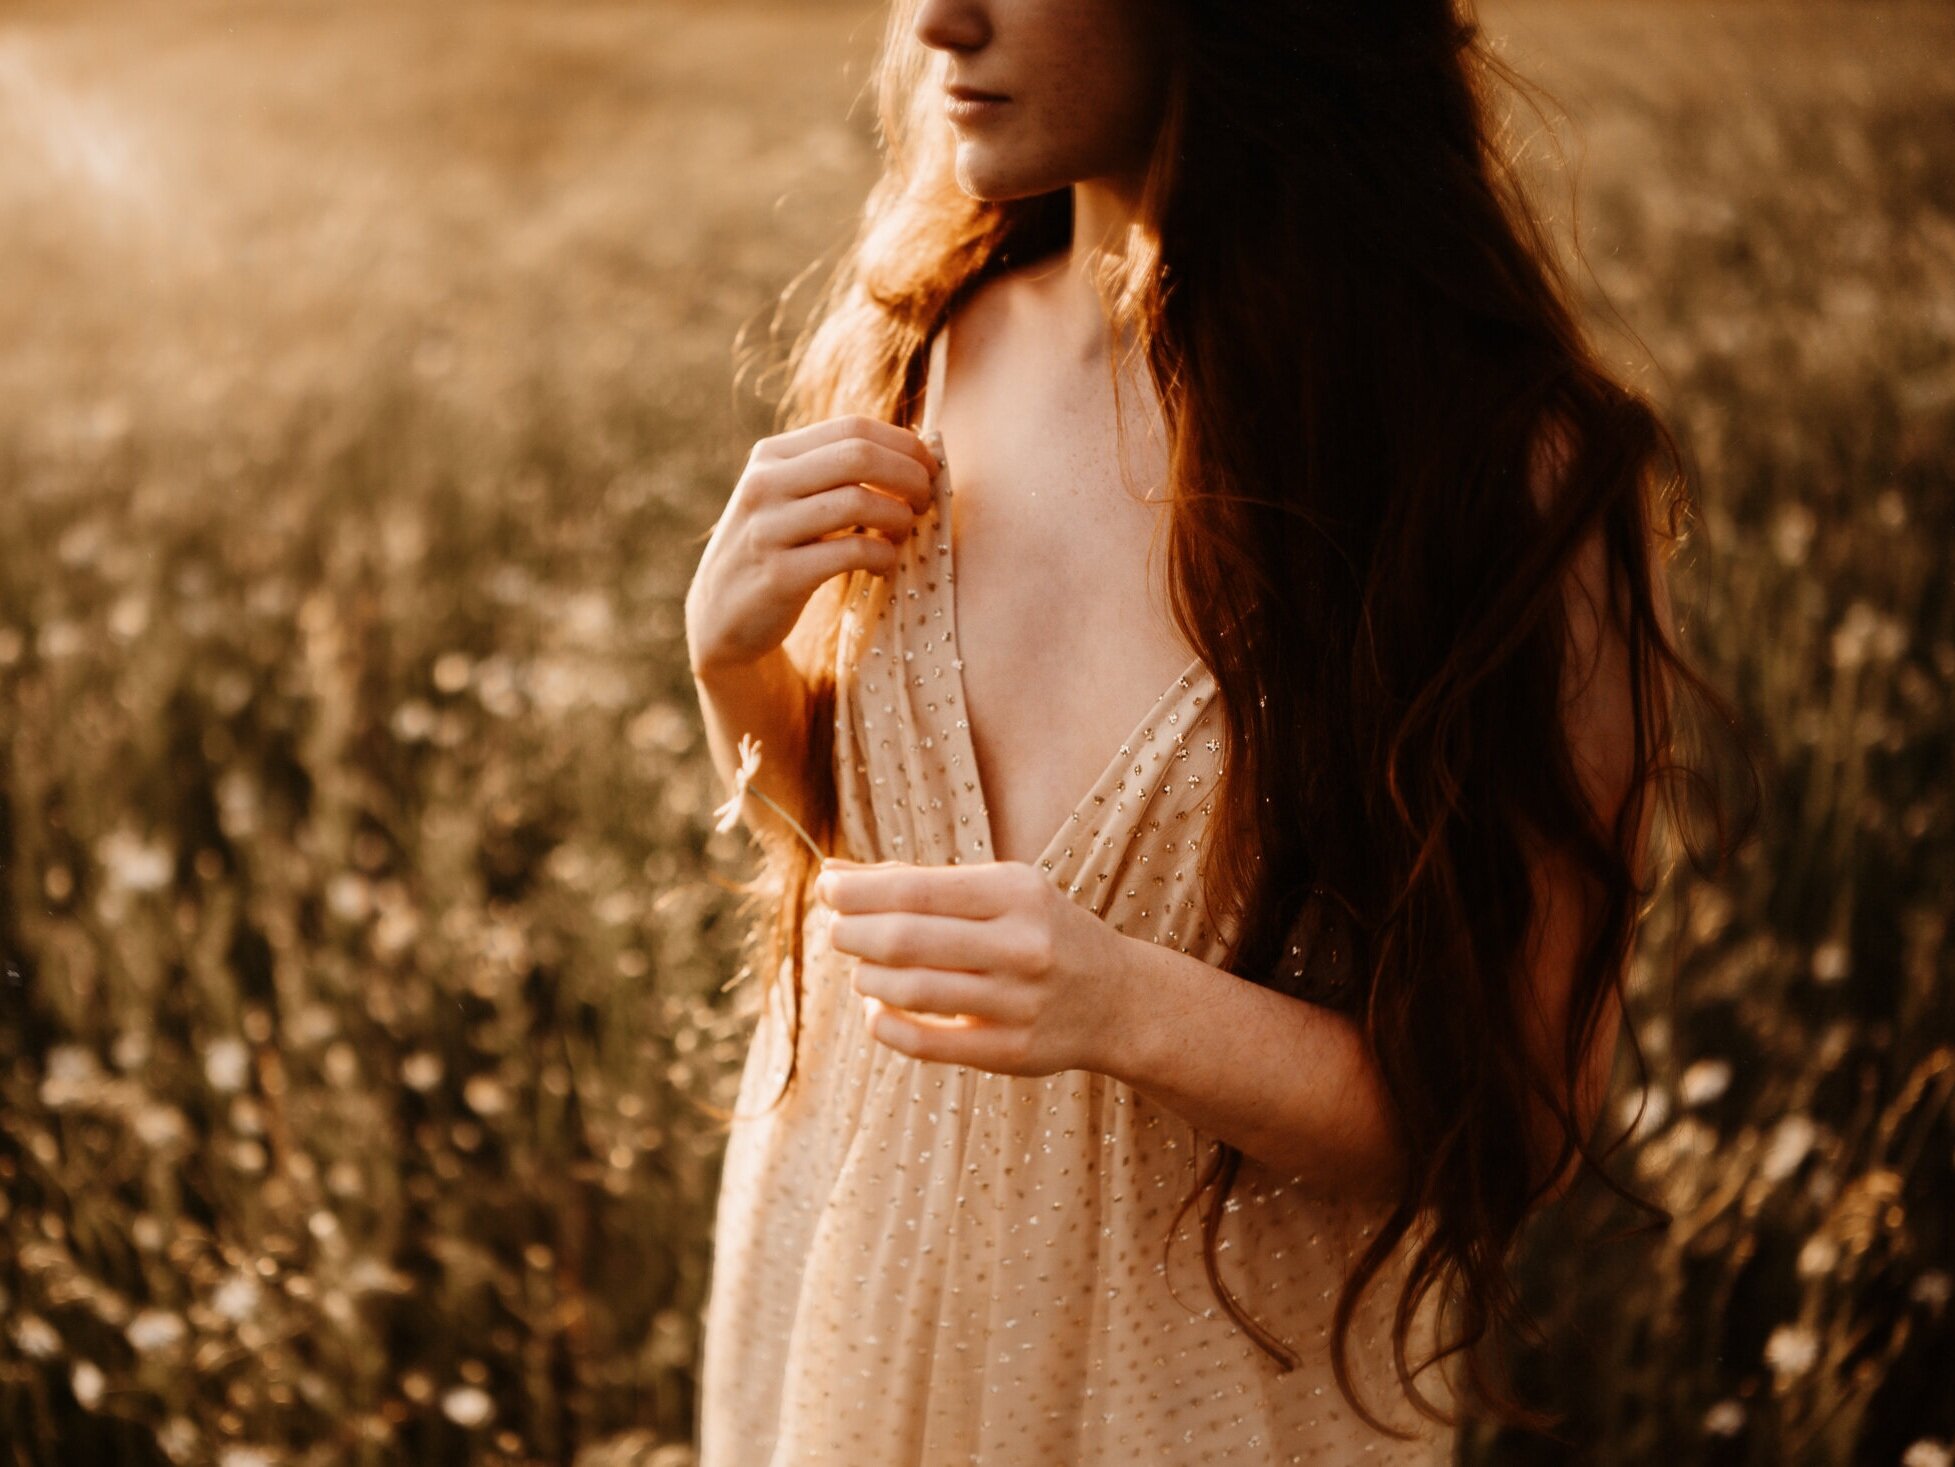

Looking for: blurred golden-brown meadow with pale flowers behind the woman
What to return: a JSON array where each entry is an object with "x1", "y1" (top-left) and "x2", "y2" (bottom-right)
[{"x1": 0, "y1": 0, "x2": 1955, "y2": 1467}]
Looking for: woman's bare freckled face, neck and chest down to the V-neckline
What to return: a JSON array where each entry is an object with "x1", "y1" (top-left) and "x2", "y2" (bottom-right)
[{"x1": 913, "y1": 0, "x2": 1195, "y2": 861}]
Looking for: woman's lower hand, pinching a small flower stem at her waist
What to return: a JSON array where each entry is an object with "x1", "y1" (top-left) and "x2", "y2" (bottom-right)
[{"x1": 815, "y1": 859, "x2": 1134, "y2": 1076}]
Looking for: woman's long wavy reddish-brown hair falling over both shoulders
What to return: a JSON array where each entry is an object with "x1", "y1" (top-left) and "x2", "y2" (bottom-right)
[{"x1": 711, "y1": 0, "x2": 1758, "y2": 1430}]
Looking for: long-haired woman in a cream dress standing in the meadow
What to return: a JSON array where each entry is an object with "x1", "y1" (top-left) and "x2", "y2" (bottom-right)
[{"x1": 686, "y1": 0, "x2": 1751, "y2": 1467}]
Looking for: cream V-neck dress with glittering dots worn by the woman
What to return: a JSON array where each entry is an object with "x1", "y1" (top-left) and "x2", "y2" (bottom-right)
[{"x1": 698, "y1": 320, "x2": 1453, "y2": 1467}]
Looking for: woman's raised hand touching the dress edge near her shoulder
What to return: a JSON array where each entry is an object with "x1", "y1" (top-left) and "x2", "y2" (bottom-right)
[{"x1": 686, "y1": 415, "x2": 938, "y2": 673}]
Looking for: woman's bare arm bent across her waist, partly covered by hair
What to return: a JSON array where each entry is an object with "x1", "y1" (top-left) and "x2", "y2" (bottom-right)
[{"x1": 817, "y1": 424, "x2": 1662, "y2": 1220}]
